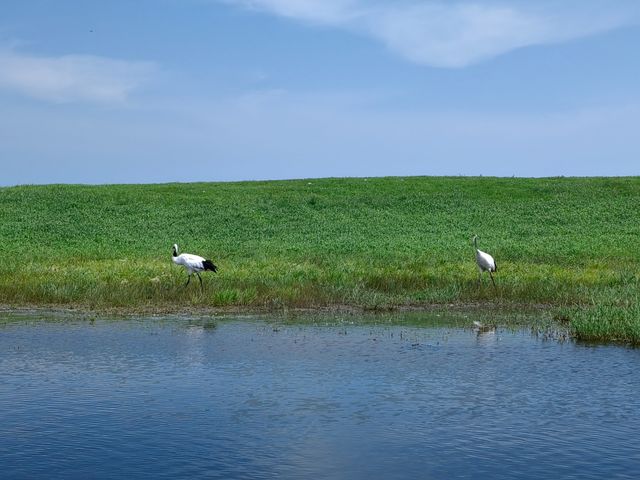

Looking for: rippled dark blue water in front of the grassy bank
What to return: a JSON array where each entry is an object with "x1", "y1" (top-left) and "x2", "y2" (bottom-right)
[{"x1": 0, "y1": 317, "x2": 640, "y2": 479}]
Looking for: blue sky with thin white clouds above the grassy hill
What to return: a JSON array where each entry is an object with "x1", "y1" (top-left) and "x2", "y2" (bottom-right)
[{"x1": 0, "y1": 0, "x2": 640, "y2": 185}]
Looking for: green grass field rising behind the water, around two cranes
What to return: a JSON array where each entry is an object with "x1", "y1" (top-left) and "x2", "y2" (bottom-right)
[{"x1": 0, "y1": 177, "x2": 640, "y2": 343}]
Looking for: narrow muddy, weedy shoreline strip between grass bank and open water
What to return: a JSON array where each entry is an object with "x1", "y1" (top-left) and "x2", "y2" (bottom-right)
[{"x1": 0, "y1": 304, "x2": 572, "y2": 341}]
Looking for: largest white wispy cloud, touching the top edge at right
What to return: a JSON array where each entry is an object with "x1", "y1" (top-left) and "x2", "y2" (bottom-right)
[{"x1": 222, "y1": 0, "x2": 640, "y2": 68}]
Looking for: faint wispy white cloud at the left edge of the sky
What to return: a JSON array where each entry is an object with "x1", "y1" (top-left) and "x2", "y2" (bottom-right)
[{"x1": 0, "y1": 49, "x2": 156, "y2": 104}]
